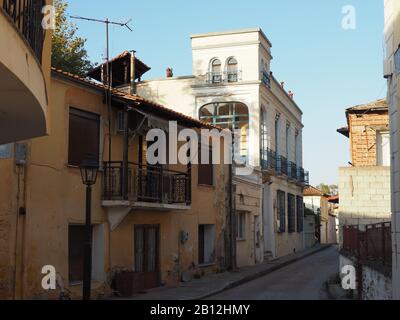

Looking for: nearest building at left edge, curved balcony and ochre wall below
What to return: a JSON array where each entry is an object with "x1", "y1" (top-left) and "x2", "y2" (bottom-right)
[{"x1": 0, "y1": 0, "x2": 52, "y2": 298}]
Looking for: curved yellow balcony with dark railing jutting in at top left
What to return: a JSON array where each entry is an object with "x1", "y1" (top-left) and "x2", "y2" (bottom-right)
[{"x1": 0, "y1": 0, "x2": 52, "y2": 145}]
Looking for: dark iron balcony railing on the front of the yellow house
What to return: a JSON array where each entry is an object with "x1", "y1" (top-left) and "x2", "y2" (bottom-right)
[{"x1": 103, "y1": 161, "x2": 191, "y2": 205}]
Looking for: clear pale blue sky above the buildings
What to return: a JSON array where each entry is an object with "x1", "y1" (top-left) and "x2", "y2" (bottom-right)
[{"x1": 68, "y1": 0, "x2": 386, "y2": 184}]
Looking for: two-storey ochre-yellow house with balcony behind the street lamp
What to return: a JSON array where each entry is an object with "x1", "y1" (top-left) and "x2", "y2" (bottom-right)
[{"x1": 0, "y1": 65, "x2": 229, "y2": 299}]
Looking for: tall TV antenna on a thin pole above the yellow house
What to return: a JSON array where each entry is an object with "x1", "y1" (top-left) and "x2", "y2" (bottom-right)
[{"x1": 70, "y1": 16, "x2": 132, "y2": 166}]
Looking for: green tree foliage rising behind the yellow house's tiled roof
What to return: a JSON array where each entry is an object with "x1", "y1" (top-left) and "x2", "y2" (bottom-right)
[{"x1": 52, "y1": 0, "x2": 93, "y2": 76}]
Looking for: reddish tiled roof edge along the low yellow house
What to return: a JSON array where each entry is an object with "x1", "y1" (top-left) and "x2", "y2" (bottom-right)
[{"x1": 52, "y1": 68, "x2": 220, "y2": 130}]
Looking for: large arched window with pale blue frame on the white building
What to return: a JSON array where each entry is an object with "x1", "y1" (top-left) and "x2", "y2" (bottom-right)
[{"x1": 200, "y1": 102, "x2": 249, "y2": 162}]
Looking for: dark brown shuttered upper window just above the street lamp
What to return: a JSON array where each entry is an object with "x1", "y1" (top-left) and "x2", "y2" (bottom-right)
[{"x1": 68, "y1": 108, "x2": 100, "y2": 166}]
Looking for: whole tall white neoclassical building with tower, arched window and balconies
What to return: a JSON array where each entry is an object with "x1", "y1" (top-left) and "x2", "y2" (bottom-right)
[{"x1": 123, "y1": 28, "x2": 308, "y2": 263}]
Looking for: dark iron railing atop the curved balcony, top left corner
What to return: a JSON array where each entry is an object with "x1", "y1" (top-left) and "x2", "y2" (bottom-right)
[{"x1": 0, "y1": 0, "x2": 46, "y2": 62}]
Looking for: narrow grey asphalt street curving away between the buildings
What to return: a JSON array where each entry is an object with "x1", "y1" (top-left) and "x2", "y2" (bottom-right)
[{"x1": 209, "y1": 247, "x2": 339, "y2": 300}]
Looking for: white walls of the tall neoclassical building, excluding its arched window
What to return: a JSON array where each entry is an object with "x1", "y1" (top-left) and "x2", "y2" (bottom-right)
[{"x1": 136, "y1": 28, "x2": 304, "y2": 256}]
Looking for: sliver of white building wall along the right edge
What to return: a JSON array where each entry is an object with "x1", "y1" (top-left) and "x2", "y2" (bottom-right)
[{"x1": 384, "y1": 0, "x2": 400, "y2": 299}]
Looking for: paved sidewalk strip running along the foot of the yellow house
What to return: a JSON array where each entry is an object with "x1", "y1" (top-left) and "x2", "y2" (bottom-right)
[{"x1": 113, "y1": 245, "x2": 331, "y2": 300}]
